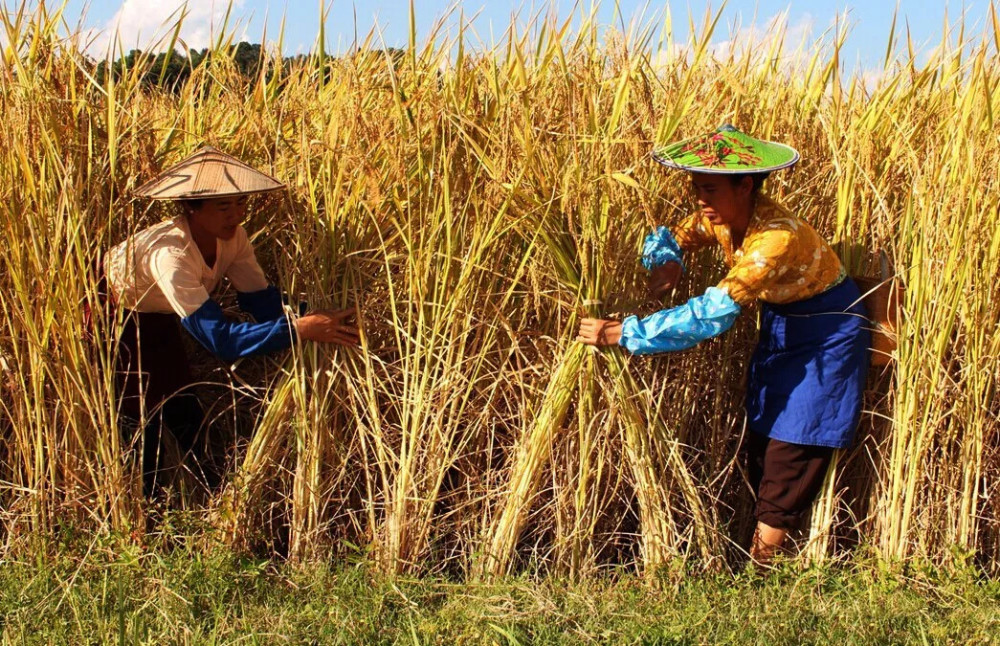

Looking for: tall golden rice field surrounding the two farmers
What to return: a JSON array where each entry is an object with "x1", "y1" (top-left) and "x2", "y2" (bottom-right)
[{"x1": 0, "y1": 5, "x2": 1000, "y2": 577}]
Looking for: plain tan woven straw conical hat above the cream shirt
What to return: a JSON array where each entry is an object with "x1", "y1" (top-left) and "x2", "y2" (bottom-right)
[{"x1": 135, "y1": 146, "x2": 285, "y2": 200}]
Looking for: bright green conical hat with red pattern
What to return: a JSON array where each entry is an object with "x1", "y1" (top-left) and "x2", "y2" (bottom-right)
[{"x1": 653, "y1": 124, "x2": 799, "y2": 174}]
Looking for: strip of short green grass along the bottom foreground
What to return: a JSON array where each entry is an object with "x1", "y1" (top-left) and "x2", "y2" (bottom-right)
[{"x1": 0, "y1": 528, "x2": 1000, "y2": 645}]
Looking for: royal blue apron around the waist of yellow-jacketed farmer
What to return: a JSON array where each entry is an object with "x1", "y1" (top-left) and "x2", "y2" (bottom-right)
[{"x1": 746, "y1": 278, "x2": 871, "y2": 449}]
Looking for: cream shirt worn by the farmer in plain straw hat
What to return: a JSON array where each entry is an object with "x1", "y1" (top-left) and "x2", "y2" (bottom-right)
[{"x1": 104, "y1": 215, "x2": 268, "y2": 317}]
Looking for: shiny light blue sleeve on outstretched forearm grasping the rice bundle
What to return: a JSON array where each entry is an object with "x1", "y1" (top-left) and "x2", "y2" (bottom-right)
[{"x1": 618, "y1": 287, "x2": 740, "y2": 354}]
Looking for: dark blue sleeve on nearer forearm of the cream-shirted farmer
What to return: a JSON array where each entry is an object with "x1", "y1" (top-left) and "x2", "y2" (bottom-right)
[{"x1": 181, "y1": 299, "x2": 294, "y2": 361}]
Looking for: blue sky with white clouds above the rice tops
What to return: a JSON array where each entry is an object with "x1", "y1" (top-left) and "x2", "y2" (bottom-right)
[{"x1": 60, "y1": 0, "x2": 989, "y2": 69}]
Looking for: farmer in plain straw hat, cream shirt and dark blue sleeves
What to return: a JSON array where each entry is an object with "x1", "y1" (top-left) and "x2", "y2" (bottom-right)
[{"x1": 104, "y1": 146, "x2": 358, "y2": 495}]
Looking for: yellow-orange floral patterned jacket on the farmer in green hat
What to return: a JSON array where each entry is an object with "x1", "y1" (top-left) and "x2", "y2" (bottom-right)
[{"x1": 671, "y1": 195, "x2": 847, "y2": 306}]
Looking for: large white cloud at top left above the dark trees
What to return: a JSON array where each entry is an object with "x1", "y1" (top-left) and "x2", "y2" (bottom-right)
[{"x1": 85, "y1": 0, "x2": 245, "y2": 58}]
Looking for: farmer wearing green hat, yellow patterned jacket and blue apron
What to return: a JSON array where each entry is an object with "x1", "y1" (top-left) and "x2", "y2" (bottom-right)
[{"x1": 578, "y1": 125, "x2": 870, "y2": 565}]
